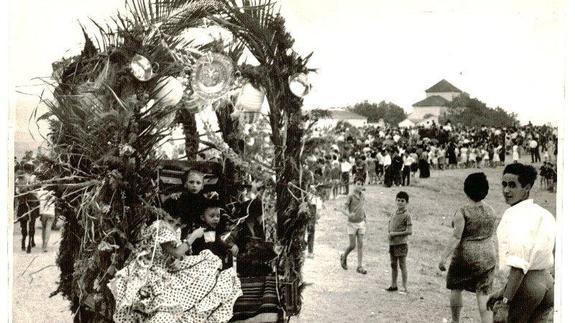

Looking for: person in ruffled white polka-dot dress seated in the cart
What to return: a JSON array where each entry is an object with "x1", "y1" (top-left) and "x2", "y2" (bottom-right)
[{"x1": 108, "y1": 214, "x2": 242, "y2": 323}]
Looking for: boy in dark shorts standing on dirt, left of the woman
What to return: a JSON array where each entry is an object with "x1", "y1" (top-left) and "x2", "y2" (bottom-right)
[{"x1": 387, "y1": 191, "x2": 411, "y2": 293}]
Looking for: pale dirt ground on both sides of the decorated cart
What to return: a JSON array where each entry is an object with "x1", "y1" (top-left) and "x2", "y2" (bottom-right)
[{"x1": 12, "y1": 158, "x2": 556, "y2": 323}]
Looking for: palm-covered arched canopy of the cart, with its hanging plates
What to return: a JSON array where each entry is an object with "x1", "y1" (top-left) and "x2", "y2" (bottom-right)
[{"x1": 39, "y1": 0, "x2": 318, "y2": 322}]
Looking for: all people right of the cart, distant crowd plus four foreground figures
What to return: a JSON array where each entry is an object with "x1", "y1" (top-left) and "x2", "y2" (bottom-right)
[{"x1": 304, "y1": 125, "x2": 557, "y2": 323}]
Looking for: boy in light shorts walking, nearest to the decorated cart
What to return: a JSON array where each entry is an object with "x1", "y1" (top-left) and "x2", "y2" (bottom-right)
[{"x1": 340, "y1": 186, "x2": 367, "y2": 275}]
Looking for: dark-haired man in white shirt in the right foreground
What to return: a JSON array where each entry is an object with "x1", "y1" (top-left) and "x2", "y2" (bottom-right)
[{"x1": 487, "y1": 163, "x2": 555, "y2": 323}]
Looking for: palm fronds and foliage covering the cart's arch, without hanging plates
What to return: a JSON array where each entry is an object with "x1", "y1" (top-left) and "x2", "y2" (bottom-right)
[{"x1": 40, "y1": 0, "x2": 316, "y2": 322}]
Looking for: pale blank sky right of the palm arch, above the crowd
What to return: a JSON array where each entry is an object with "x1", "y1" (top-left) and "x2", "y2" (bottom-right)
[{"x1": 284, "y1": 0, "x2": 566, "y2": 123}]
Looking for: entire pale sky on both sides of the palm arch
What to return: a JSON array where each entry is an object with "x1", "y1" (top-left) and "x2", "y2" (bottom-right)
[{"x1": 9, "y1": 0, "x2": 566, "y2": 134}]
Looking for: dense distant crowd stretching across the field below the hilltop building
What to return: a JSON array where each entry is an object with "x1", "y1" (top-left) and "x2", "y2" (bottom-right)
[{"x1": 304, "y1": 123, "x2": 557, "y2": 199}]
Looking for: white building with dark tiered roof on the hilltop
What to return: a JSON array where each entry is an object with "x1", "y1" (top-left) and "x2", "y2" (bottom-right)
[{"x1": 399, "y1": 80, "x2": 463, "y2": 127}]
